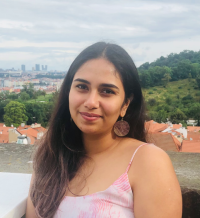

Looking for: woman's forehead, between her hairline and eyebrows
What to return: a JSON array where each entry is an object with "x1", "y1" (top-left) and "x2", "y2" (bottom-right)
[{"x1": 74, "y1": 58, "x2": 122, "y2": 86}]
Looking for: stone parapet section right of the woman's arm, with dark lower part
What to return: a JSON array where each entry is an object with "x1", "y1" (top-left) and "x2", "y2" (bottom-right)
[{"x1": 167, "y1": 152, "x2": 200, "y2": 218}]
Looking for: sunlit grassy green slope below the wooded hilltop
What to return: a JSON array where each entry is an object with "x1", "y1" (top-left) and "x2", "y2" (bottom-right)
[{"x1": 143, "y1": 79, "x2": 200, "y2": 126}]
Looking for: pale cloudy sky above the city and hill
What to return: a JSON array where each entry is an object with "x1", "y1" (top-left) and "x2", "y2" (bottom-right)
[{"x1": 0, "y1": 0, "x2": 200, "y2": 71}]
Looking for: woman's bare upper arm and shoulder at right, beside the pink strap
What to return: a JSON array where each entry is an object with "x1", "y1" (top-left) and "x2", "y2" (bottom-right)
[{"x1": 132, "y1": 145, "x2": 182, "y2": 218}]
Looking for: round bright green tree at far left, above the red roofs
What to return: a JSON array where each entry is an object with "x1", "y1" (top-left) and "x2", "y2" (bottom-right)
[{"x1": 4, "y1": 101, "x2": 28, "y2": 127}]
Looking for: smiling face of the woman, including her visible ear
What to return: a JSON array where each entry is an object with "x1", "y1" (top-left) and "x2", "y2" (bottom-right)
[{"x1": 69, "y1": 58, "x2": 129, "y2": 134}]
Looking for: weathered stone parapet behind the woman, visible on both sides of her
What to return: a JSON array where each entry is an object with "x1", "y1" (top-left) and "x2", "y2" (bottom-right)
[{"x1": 0, "y1": 144, "x2": 200, "y2": 218}]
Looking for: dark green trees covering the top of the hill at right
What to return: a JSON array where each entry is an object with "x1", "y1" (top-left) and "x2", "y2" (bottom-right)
[{"x1": 138, "y1": 50, "x2": 200, "y2": 88}]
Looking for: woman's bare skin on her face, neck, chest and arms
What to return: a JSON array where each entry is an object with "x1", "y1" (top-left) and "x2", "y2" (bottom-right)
[{"x1": 26, "y1": 58, "x2": 182, "y2": 218}]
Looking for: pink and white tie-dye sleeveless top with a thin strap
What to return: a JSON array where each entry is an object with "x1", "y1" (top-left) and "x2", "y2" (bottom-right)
[{"x1": 54, "y1": 143, "x2": 147, "y2": 218}]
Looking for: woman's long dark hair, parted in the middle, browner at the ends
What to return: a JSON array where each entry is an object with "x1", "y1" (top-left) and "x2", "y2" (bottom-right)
[{"x1": 31, "y1": 42, "x2": 146, "y2": 218}]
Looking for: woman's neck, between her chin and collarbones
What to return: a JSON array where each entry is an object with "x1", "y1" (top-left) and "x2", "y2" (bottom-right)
[{"x1": 83, "y1": 132, "x2": 121, "y2": 156}]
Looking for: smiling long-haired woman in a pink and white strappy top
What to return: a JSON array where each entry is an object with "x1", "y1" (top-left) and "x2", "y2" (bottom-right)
[{"x1": 26, "y1": 42, "x2": 182, "y2": 218}]
